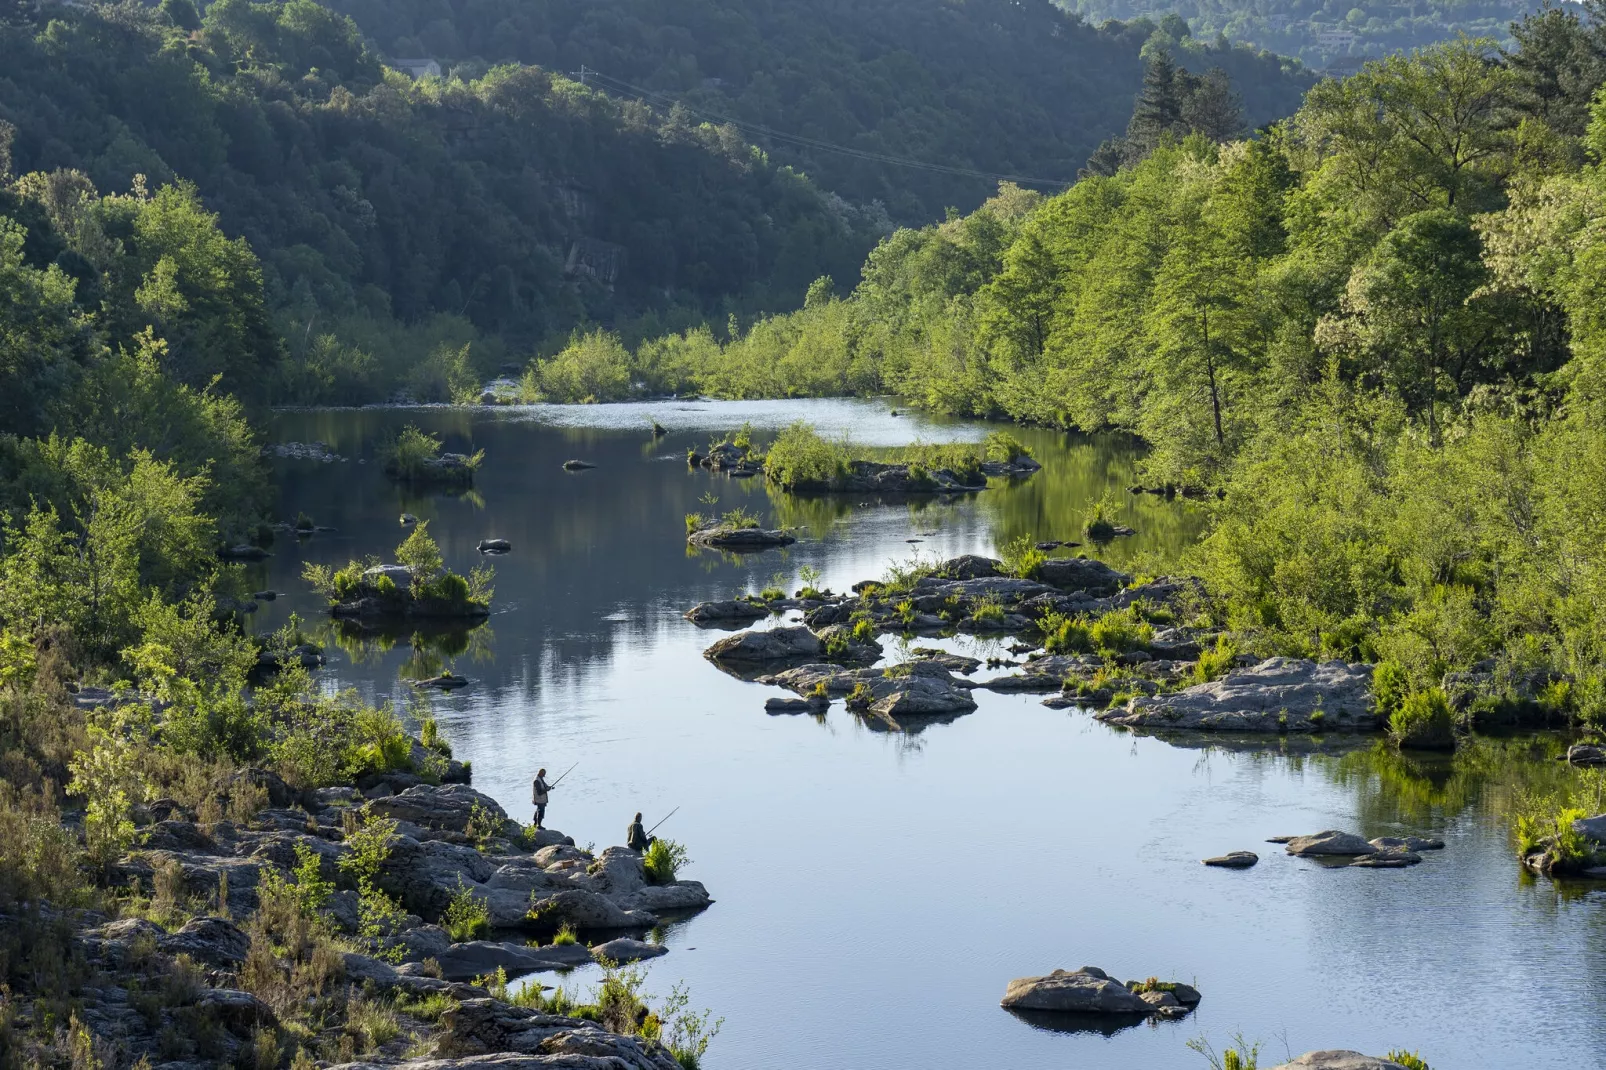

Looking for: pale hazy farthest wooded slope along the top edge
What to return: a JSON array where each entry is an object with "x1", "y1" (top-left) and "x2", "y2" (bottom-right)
[{"x1": 1060, "y1": 0, "x2": 1540, "y2": 67}]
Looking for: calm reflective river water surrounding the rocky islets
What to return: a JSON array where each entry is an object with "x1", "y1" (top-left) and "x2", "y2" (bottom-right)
[{"x1": 257, "y1": 402, "x2": 1606, "y2": 1070}]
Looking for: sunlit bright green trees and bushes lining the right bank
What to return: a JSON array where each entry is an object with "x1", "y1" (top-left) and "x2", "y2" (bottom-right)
[{"x1": 549, "y1": 10, "x2": 1606, "y2": 721}]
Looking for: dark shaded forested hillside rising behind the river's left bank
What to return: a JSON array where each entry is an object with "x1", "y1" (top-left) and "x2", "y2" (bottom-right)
[{"x1": 0, "y1": 0, "x2": 885, "y2": 402}]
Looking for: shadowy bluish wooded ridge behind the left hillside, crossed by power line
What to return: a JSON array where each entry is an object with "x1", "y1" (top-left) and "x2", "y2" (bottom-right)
[{"x1": 319, "y1": 0, "x2": 1310, "y2": 220}]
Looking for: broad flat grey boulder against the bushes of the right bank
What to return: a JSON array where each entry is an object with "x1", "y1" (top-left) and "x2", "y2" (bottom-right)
[{"x1": 1097, "y1": 657, "x2": 1378, "y2": 733}]
